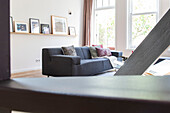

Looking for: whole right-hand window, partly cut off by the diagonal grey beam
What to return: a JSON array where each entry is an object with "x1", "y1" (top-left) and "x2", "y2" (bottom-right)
[{"x1": 128, "y1": 0, "x2": 159, "y2": 49}]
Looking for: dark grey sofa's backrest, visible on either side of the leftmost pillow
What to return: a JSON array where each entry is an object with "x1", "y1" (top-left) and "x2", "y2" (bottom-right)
[{"x1": 43, "y1": 47, "x2": 91, "y2": 59}]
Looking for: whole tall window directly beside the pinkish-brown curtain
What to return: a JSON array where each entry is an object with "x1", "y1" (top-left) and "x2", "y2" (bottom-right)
[{"x1": 92, "y1": 0, "x2": 115, "y2": 47}]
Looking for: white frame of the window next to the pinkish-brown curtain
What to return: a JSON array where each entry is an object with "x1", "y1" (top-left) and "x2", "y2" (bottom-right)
[{"x1": 91, "y1": 0, "x2": 116, "y2": 46}]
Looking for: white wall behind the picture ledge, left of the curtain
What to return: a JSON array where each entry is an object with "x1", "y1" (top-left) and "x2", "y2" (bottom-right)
[{"x1": 11, "y1": 0, "x2": 83, "y2": 73}]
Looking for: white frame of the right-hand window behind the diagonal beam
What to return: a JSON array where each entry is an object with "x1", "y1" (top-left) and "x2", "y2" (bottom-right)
[{"x1": 126, "y1": 0, "x2": 160, "y2": 50}]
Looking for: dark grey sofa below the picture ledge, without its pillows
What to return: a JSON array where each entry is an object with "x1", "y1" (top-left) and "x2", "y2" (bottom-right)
[{"x1": 42, "y1": 47, "x2": 122, "y2": 76}]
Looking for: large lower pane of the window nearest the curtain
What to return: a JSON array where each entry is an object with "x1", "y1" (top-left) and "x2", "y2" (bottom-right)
[{"x1": 95, "y1": 9, "x2": 115, "y2": 47}]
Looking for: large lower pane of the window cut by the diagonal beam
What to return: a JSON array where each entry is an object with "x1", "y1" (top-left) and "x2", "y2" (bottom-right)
[{"x1": 131, "y1": 14, "x2": 156, "y2": 48}]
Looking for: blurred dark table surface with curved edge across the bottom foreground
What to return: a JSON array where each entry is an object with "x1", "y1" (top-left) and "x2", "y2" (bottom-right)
[{"x1": 0, "y1": 76, "x2": 170, "y2": 113}]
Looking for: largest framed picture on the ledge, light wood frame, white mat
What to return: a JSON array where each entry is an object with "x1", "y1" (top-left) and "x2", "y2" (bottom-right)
[{"x1": 51, "y1": 16, "x2": 68, "y2": 35}]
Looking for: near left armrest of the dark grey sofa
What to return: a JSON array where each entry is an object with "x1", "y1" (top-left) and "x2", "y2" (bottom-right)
[{"x1": 51, "y1": 55, "x2": 81, "y2": 65}]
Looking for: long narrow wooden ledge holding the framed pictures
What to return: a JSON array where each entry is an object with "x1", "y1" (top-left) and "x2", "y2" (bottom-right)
[{"x1": 10, "y1": 32, "x2": 76, "y2": 37}]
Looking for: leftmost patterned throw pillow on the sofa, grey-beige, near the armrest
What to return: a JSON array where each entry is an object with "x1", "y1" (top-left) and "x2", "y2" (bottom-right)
[{"x1": 61, "y1": 46, "x2": 77, "y2": 56}]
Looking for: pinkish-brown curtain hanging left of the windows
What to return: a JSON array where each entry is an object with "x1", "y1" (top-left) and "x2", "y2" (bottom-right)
[{"x1": 83, "y1": 0, "x2": 93, "y2": 46}]
